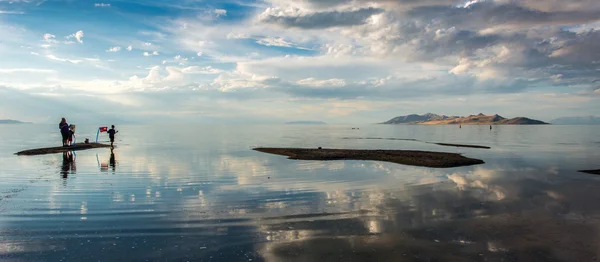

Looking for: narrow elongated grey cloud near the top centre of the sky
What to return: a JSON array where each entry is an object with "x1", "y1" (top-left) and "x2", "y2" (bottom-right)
[{"x1": 262, "y1": 8, "x2": 384, "y2": 29}]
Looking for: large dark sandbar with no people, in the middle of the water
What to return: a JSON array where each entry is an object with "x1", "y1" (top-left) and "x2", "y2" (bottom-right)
[{"x1": 254, "y1": 148, "x2": 485, "y2": 168}]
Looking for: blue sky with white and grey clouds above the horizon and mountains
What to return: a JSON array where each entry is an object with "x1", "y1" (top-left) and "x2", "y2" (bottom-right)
[{"x1": 0, "y1": 0, "x2": 600, "y2": 123}]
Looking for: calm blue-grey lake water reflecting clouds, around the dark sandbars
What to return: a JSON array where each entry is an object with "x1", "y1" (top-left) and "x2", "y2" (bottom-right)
[{"x1": 0, "y1": 125, "x2": 600, "y2": 261}]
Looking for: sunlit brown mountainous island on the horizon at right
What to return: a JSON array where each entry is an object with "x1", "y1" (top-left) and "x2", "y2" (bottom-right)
[{"x1": 382, "y1": 113, "x2": 548, "y2": 125}]
